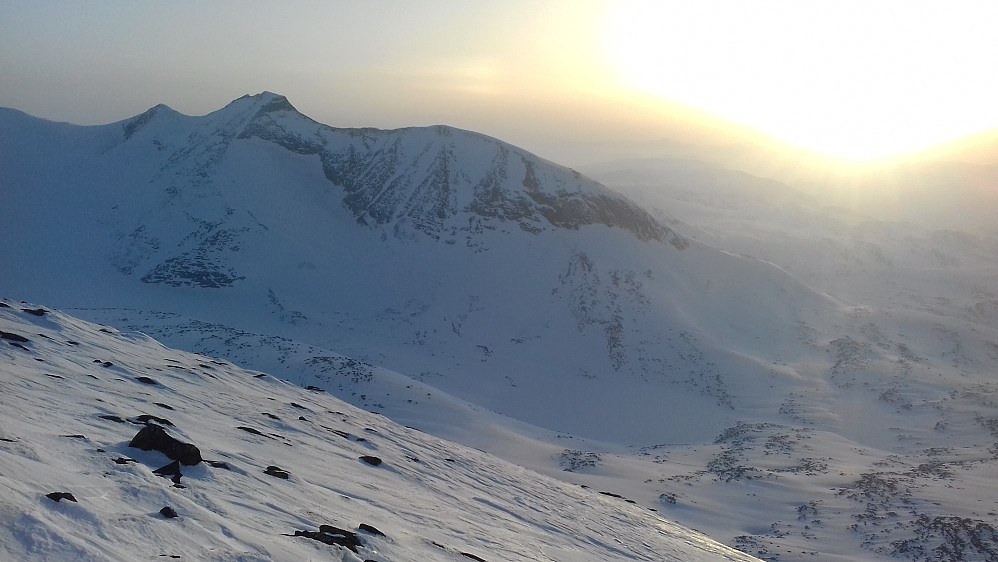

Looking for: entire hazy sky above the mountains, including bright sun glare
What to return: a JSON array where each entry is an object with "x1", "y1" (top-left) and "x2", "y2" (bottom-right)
[{"x1": 0, "y1": 0, "x2": 998, "y2": 162}]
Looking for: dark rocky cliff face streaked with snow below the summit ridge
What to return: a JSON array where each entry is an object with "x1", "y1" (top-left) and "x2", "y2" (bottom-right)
[{"x1": 229, "y1": 96, "x2": 688, "y2": 245}]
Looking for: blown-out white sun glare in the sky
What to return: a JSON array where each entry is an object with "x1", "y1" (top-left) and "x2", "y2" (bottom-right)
[{"x1": 603, "y1": 0, "x2": 998, "y2": 160}]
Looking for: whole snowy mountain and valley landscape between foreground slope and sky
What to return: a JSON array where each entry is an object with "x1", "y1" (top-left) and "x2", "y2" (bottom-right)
[{"x1": 0, "y1": 94, "x2": 998, "y2": 560}]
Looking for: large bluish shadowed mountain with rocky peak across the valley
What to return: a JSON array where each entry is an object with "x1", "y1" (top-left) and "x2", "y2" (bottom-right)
[{"x1": 0, "y1": 93, "x2": 832, "y2": 443}]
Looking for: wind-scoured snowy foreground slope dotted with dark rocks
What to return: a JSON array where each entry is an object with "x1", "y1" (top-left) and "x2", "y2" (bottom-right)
[{"x1": 0, "y1": 303, "x2": 752, "y2": 561}]
